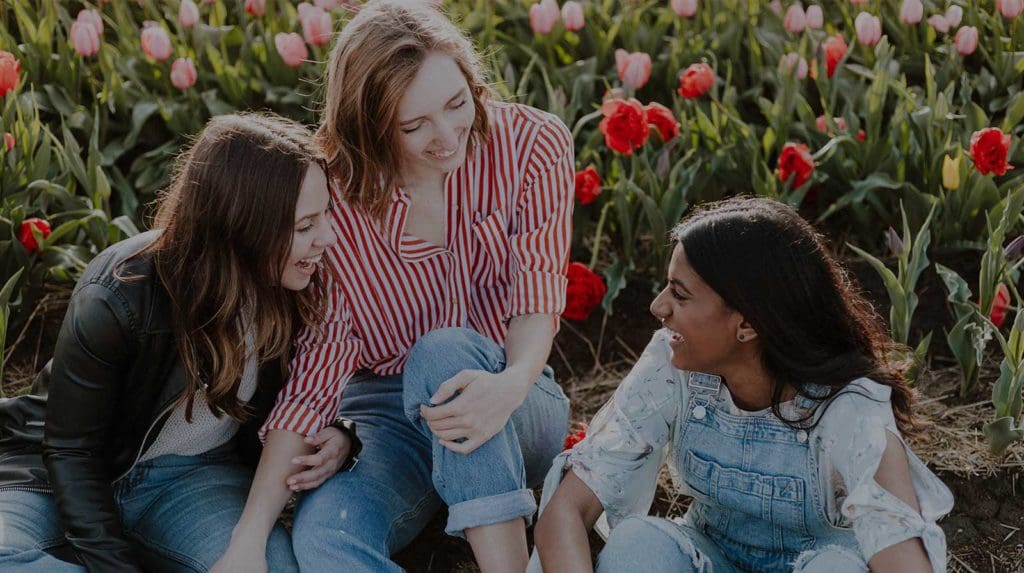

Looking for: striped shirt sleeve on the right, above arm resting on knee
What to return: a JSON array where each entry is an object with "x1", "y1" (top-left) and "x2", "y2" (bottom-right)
[{"x1": 509, "y1": 116, "x2": 574, "y2": 318}]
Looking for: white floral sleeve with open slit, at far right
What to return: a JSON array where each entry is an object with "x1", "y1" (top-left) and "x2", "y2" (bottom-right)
[{"x1": 818, "y1": 380, "x2": 953, "y2": 573}]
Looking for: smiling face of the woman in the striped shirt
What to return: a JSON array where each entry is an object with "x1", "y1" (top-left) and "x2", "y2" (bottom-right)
[{"x1": 398, "y1": 52, "x2": 476, "y2": 185}]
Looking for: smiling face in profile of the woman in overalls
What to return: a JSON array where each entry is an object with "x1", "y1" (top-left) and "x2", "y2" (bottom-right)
[{"x1": 650, "y1": 245, "x2": 756, "y2": 376}]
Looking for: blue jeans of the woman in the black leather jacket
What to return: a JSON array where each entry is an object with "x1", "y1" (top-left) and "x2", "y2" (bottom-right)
[{"x1": 0, "y1": 442, "x2": 298, "y2": 573}]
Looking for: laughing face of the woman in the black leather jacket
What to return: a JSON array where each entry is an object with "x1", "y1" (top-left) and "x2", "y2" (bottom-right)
[{"x1": 281, "y1": 163, "x2": 337, "y2": 291}]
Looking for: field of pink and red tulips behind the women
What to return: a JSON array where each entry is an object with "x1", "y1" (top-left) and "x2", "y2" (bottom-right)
[{"x1": 6, "y1": 0, "x2": 1024, "y2": 570}]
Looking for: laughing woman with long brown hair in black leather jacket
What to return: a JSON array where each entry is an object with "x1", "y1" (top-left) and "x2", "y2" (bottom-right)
[{"x1": 0, "y1": 115, "x2": 350, "y2": 572}]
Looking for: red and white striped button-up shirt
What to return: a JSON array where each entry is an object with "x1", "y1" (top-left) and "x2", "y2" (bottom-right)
[{"x1": 261, "y1": 102, "x2": 574, "y2": 435}]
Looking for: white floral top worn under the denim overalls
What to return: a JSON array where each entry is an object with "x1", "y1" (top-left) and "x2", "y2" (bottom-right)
[{"x1": 541, "y1": 330, "x2": 953, "y2": 572}]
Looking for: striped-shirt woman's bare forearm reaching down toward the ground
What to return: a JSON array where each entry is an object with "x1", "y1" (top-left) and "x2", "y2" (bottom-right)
[{"x1": 232, "y1": 430, "x2": 313, "y2": 545}]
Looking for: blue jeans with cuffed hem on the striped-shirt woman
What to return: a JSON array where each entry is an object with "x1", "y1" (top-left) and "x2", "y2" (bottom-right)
[{"x1": 292, "y1": 328, "x2": 568, "y2": 572}]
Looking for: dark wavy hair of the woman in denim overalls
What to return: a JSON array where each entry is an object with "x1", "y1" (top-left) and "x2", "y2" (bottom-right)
[{"x1": 672, "y1": 196, "x2": 916, "y2": 434}]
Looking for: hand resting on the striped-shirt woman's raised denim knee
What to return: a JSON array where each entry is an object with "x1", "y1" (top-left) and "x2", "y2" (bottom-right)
[{"x1": 420, "y1": 370, "x2": 529, "y2": 454}]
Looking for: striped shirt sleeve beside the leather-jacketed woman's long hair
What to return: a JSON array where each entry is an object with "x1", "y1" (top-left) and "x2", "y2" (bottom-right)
[{"x1": 259, "y1": 281, "x2": 362, "y2": 441}]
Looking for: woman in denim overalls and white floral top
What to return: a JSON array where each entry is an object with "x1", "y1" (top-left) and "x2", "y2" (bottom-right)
[{"x1": 532, "y1": 197, "x2": 952, "y2": 573}]
